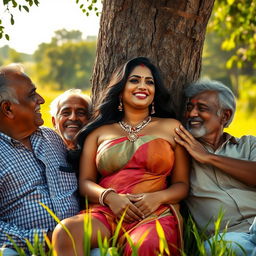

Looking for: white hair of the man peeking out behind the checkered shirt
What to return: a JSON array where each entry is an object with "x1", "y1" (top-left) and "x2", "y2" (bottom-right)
[{"x1": 50, "y1": 89, "x2": 92, "y2": 117}]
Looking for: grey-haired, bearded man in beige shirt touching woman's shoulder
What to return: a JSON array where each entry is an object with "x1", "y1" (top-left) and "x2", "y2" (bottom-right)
[{"x1": 176, "y1": 80, "x2": 256, "y2": 255}]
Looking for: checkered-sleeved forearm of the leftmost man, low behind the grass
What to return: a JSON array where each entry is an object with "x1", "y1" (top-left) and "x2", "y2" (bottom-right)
[{"x1": 0, "y1": 220, "x2": 47, "y2": 248}]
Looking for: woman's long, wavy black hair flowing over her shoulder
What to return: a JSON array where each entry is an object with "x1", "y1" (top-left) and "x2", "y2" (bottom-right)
[{"x1": 68, "y1": 57, "x2": 175, "y2": 168}]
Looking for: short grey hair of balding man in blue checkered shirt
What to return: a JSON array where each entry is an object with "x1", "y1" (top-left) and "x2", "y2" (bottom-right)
[{"x1": 0, "y1": 63, "x2": 24, "y2": 104}]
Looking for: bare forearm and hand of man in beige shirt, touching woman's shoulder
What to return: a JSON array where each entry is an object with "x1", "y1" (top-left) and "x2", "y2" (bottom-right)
[{"x1": 175, "y1": 126, "x2": 256, "y2": 186}]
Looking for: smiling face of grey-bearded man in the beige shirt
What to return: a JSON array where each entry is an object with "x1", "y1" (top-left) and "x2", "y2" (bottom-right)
[{"x1": 185, "y1": 91, "x2": 223, "y2": 138}]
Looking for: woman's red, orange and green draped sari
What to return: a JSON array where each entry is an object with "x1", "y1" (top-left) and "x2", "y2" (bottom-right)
[{"x1": 87, "y1": 135, "x2": 182, "y2": 255}]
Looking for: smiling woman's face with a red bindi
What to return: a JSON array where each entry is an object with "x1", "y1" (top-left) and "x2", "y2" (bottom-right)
[{"x1": 122, "y1": 65, "x2": 155, "y2": 110}]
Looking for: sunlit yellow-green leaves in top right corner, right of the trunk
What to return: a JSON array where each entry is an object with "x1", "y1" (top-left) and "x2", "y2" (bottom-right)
[{"x1": 208, "y1": 0, "x2": 256, "y2": 68}]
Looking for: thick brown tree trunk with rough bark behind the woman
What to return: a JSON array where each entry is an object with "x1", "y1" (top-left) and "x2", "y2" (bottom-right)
[{"x1": 92, "y1": 0, "x2": 214, "y2": 114}]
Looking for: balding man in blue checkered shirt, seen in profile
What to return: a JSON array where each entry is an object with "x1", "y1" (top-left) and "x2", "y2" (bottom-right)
[{"x1": 0, "y1": 65, "x2": 79, "y2": 255}]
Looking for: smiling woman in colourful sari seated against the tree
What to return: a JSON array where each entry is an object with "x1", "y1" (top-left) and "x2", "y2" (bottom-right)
[{"x1": 53, "y1": 57, "x2": 189, "y2": 256}]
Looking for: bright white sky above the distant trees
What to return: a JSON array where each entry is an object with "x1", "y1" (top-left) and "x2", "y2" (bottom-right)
[{"x1": 0, "y1": 0, "x2": 101, "y2": 54}]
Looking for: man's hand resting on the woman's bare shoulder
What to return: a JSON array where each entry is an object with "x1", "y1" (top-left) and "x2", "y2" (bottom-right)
[{"x1": 174, "y1": 125, "x2": 210, "y2": 164}]
